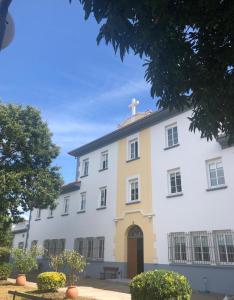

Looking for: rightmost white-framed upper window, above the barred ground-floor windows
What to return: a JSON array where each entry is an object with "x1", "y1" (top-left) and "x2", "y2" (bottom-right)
[{"x1": 207, "y1": 158, "x2": 225, "y2": 188}]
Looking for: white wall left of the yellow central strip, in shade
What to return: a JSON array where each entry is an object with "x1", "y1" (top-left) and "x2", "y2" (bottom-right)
[{"x1": 28, "y1": 143, "x2": 117, "y2": 261}]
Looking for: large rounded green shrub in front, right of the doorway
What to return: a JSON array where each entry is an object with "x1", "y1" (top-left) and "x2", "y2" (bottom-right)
[{"x1": 130, "y1": 270, "x2": 192, "y2": 300}]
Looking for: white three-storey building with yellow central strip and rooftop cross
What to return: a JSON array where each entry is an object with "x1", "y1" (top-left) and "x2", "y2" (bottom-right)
[{"x1": 28, "y1": 102, "x2": 234, "y2": 294}]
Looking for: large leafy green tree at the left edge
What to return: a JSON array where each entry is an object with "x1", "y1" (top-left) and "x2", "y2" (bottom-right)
[{"x1": 0, "y1": 103, "x2": 62, "y2": 222}]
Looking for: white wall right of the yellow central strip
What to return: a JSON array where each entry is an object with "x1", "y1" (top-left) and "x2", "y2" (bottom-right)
[{"x1": 151, "y1": 112, "x2": 234, "y2": 264}]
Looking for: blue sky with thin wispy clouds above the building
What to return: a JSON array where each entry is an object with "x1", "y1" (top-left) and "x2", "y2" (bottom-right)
[{"x1": 0, "y1": 0, "x2": 155, "y2": 182}]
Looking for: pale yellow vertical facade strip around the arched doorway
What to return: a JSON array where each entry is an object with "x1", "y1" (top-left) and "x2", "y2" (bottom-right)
[{"x1": 115, "y1": 128, "x2": 156, "y2": 263}]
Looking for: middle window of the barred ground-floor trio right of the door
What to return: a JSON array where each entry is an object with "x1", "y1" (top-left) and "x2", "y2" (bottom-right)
[{"x1": 191, "y1": 232, "x2": 210, "y2": 262}]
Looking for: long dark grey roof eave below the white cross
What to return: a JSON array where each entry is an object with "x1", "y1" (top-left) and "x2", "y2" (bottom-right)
[{"x1": 68, "y1": 109, "x2": 186, "y2": 157}]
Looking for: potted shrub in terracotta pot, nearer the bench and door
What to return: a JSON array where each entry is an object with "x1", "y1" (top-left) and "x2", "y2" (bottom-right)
[{"x1": 63, "y1": 250, "x2": 86, "y2": 299}]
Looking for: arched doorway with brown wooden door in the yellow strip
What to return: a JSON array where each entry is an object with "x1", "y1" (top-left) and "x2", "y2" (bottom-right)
[{"x1": 127, "y1": 225, "x2": 144, "y2": 278}]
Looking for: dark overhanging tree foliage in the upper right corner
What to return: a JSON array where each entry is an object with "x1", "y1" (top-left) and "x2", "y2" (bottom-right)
[{"x1": 78, "y1": 0, "x2": 234, "y2": 141}]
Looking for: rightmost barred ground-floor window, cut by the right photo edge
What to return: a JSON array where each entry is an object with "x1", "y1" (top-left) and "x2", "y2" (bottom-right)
[{"x1": 214, "y1": 231, "x2": 234, "y2": 263}]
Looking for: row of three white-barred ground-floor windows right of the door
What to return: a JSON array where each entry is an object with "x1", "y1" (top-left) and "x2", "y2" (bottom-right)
[{"x1": 168, "y1": 230, "x2": 234, "y2": 264}]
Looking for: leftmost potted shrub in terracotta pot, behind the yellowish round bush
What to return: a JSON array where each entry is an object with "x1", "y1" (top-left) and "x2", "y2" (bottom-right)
[{"x1": 11, "y1": 246, "x2": 42, "y2": 286}]
